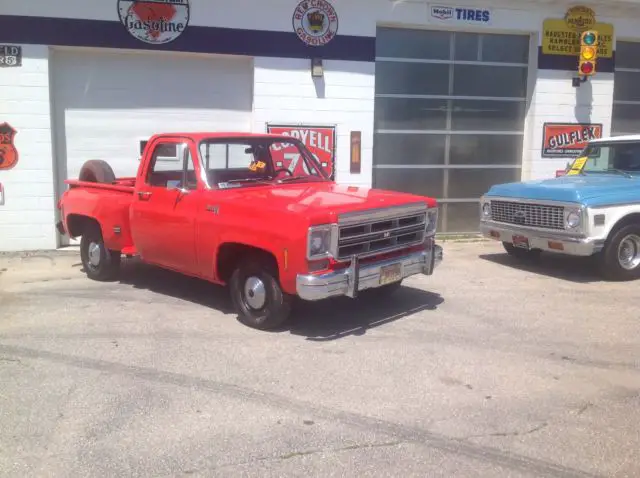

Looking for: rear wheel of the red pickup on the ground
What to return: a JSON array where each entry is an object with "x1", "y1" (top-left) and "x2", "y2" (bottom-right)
[{"x1": 80, "y1": 224, "x2": 121, "y2": 281}]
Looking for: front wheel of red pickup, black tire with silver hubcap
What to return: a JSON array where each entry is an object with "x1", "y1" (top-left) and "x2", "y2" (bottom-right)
[{"x1": 229, "y1": 257, "x2": 293, "y2": 330}]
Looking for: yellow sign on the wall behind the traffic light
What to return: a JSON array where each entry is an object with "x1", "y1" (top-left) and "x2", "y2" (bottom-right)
[{"x1": 542, "y1": 18, "x2": 613, "y2": 58}]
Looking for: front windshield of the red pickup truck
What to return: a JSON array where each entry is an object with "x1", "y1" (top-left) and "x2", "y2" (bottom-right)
[{"x1": 199, "y1": 137, "x2": 328, "y2": 188}]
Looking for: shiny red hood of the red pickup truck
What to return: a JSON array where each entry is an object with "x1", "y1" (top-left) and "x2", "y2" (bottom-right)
[{"x1": 215, "y1": 182, "x2": 436, "y2": 223}]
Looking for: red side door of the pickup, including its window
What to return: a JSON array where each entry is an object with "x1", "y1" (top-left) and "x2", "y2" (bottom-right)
[{"x1": 130, "y1": 137, "x2": 203, "y2": 274}]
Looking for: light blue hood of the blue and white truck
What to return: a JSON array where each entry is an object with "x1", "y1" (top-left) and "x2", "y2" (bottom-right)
[{"x1": 486, "y1": 173, "x2": 640, "y2": 203}]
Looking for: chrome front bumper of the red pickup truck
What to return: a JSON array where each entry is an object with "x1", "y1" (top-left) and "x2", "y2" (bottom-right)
[{"x1": 296, "y1": 244, "x2": 443, "y2": 301}]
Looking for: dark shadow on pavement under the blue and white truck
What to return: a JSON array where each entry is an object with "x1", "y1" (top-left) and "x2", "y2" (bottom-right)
[{"x1": 479, "y1": 252, "x2": 602, "y2": 284}]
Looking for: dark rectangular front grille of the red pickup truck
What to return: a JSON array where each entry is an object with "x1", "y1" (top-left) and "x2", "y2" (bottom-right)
[{"x1": 337, "y1": 207, "x2": 427, "y2": 259}]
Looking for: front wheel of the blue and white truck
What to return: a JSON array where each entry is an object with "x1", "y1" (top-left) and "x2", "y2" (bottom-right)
[{"x1": 596, "y1": 224, "x2": 640, "y2": 281}]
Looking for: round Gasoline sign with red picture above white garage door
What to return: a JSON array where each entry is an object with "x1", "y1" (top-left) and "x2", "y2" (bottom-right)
[{"x1": 118, "y1": 0, "x2": 189, "y2": 45}]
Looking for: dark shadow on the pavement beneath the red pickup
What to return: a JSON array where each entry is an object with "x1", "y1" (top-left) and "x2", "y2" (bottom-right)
[{"x1": 110, "y1": 259, "x2": 444, "y2": 341}]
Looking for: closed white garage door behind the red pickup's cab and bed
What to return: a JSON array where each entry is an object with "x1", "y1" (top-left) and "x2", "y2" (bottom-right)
[{"x1": 52, "y1": 46, "x2": 253, "y2": 243}]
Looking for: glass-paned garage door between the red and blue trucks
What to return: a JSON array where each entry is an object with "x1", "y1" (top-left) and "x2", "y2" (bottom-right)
[{"x1": 373, "y1": 27, "x2": 531, "y2": 232}]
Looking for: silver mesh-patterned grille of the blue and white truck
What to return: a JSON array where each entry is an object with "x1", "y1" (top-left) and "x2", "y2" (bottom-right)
[{"x1": 491, "y1": 201, "x2": 564, "y2": 230}]
